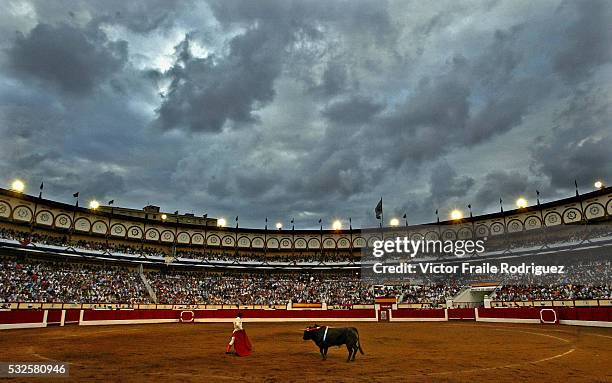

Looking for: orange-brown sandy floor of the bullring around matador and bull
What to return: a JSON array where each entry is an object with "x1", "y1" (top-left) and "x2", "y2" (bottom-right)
[{"x1": 0, "y1": 322, "x2": 612, "y2": 382}]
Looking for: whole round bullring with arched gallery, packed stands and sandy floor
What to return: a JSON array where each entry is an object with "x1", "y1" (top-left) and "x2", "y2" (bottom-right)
[{"x1": 0, "y1": 188, "x2": 612, "y2": 382}]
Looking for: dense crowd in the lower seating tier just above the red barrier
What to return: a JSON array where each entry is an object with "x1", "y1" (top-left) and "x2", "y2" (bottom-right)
[{"x1": 0, "y1": 257, "x2": 612, "y2": 306}]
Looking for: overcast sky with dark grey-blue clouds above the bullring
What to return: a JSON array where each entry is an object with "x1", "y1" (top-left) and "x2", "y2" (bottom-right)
[{"x1": 0, "y1": 0, "x2": 612, "y2": 228}]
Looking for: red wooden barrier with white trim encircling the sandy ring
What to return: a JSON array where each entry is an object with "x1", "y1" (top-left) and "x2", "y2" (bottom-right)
[{"x1": 0, "y1": 307, "x2": 612, "y2": 329}]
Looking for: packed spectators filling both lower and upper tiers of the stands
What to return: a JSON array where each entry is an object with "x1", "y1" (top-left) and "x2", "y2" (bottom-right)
[{"x1": 0, "y1": 225, "x2": 612, "y2": 306}]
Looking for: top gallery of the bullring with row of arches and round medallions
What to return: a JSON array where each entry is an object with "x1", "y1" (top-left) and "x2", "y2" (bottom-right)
[{"x1": 0, "y1": 182, "x2": 612, "y2": 253}]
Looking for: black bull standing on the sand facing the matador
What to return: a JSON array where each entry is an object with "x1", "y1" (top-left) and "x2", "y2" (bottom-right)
[{"x1": 304, "y1": 325, "x2": 363, "y2": 362}]
